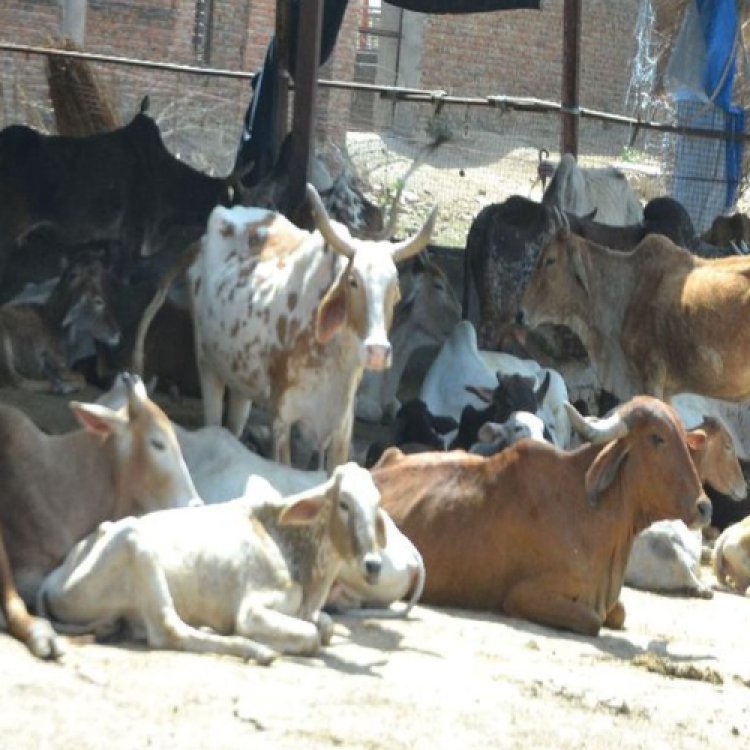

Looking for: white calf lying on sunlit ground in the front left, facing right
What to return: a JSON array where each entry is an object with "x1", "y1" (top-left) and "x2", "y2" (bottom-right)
[{"x1": 37, "y1": 464, "x2": 385, "y2": 664}]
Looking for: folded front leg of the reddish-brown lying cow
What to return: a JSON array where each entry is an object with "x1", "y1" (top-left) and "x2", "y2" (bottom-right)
[{"x1": 502, "y1": 578, "x2": 602, "y2": 635}]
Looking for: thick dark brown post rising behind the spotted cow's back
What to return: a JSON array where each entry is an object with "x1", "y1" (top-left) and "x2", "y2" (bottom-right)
[{"x1": 287, "y1": 0, "x2": 323, "y2": 223}]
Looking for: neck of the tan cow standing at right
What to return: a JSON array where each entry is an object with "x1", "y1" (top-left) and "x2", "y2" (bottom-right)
[{"x1": 574, "y1": 243, "x2": 643, "y2": 401}]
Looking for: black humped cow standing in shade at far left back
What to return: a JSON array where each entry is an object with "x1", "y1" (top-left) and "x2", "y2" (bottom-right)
[{"x1": 0, "y1": 111, "x2": 237, "y2": 296}]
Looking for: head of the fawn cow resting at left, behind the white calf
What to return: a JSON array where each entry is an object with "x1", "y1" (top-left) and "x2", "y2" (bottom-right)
[{"x1": 70, "y1": 376, "x2": 201, "y2": 513}]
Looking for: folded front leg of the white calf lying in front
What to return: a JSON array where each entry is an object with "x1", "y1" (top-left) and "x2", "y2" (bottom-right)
[{"x1": 236, "y1": 600, "x2": 322, "y2": 656}]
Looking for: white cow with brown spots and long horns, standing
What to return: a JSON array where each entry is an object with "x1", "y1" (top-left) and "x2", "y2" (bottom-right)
[{"x1": 143, "y1": 185, "x2": 437, "y2": 473}]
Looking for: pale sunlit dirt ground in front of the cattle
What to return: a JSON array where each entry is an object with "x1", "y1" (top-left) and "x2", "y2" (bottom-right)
[{"x1": 0, "y1": 389, "x2": 750, "y2": 750}]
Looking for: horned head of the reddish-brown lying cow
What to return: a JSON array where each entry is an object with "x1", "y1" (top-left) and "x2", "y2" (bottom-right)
[{"x1": 566, "y1": 396, "x2": 711, "y2": 531}]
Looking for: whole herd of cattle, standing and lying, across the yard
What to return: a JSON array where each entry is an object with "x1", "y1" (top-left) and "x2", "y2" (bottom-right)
[{"x1": 0, "y1": 112, "x2": 750, "y2": 664}]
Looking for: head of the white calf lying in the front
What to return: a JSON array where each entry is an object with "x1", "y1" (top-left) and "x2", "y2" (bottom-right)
[{"x1": 279, "y1": 463, "x2": 386, "y2": 585}]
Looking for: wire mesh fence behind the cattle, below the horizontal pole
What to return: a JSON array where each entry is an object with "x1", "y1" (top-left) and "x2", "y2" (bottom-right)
[{"x1": 0, "y1": 1, "x2": 744, "y2": 248}]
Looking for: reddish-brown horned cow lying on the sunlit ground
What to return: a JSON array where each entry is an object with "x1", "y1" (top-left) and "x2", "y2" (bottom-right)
[{"x1": 371, "y1": 396, "x2": 711, "y2": 635}]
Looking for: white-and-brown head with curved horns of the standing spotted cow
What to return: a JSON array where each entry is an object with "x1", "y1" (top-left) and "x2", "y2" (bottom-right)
[{"x1": 307, "y1": 184, "x2": 437, "y2": 370}]
